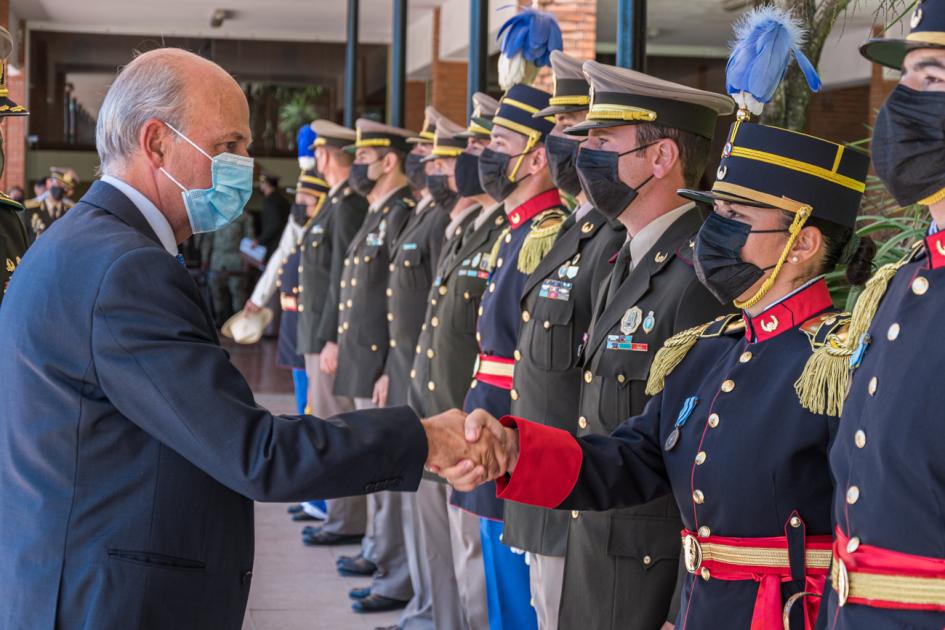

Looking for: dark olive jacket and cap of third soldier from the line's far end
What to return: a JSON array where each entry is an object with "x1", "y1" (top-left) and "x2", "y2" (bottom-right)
[{"x1": 335, "y1": 119, "x2": 416, "y2": 399}]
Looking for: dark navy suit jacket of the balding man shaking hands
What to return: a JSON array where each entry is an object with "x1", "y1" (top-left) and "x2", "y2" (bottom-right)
[{"x1": 0, "y1": 182, "x2": 426, "y2": 630}]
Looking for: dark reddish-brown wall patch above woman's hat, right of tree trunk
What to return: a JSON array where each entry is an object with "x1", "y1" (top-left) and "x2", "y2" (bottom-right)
[{"x1": 805, "y1": 84, "x2": 871, "y2": 142}]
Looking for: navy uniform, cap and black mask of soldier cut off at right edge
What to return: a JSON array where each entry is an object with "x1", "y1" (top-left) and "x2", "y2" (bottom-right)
[{"x1": 812, "y1": 0, "x2": 945, "y2": 630}]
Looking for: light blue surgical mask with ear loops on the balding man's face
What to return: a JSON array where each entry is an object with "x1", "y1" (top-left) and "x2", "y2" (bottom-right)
[{"x1": 161, "y1": 123, "x2": 253, "y2": 234}]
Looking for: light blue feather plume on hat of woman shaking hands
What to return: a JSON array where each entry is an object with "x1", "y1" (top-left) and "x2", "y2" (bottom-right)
[{"x1": 725, "y1": 6, "x2": 821, "y2": 115}]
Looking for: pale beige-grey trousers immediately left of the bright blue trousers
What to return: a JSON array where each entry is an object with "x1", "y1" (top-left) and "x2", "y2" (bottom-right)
[{"x1": 447, "y1": 494, "x2": 489, "y2": 630}]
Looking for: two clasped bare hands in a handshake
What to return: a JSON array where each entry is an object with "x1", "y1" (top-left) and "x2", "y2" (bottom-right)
[{"x1": 422, "y1": 409, "x2": 518, "y2": 492}]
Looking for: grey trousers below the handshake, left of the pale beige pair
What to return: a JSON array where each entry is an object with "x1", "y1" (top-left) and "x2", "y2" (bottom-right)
[{"x1": 400, "y1": 479, "x2": 464, "y2": 630}]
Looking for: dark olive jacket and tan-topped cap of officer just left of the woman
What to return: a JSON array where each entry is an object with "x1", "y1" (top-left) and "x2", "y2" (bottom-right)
[{"x1": 559, "y1": 61, "x2": 734, "y2": 630}]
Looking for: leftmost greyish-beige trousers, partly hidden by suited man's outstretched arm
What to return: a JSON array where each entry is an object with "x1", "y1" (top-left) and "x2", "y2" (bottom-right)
[{"x1": 305, "y1": 354, "x2": 367, "y2": 535}]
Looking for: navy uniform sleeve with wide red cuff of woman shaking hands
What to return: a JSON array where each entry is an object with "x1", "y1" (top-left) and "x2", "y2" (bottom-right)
[{"x1": 496, "y1": 394, "x2": 671, "y2": 511}]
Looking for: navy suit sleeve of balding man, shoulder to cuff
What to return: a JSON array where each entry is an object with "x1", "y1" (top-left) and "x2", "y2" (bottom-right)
[{"x1": 92, "y1": 247, "x2": 427, "y2": 501}]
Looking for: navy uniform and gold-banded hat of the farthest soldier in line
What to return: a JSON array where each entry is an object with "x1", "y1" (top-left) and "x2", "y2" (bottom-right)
[{"x1": 276, "y1": 170, "x2": 330, "y2": 372}]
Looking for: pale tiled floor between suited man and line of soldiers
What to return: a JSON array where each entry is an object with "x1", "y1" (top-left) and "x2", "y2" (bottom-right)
[{"x1": 228, "y1": 341, "x2": 399, "y2": 630}]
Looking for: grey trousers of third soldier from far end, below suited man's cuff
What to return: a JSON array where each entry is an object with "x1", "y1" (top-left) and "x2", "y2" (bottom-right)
[{"x1": 354, "y1": 398, "x2": 413, "y2": 601}]
